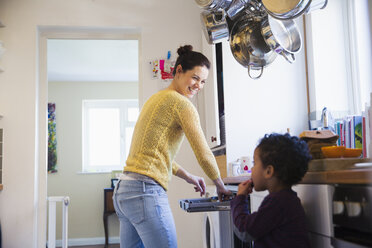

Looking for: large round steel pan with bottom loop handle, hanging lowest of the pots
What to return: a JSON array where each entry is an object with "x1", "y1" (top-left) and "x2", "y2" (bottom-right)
[{"x1": 230, "y1": 16, "x2": 277, "y2": 79}]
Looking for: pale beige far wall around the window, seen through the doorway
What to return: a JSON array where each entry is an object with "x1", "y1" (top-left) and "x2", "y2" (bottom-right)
[{"x1": 47, "y1": 82, "x2": 138, "y2": 240}]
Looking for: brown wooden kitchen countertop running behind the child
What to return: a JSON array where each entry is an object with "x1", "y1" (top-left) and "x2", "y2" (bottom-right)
[{"x1": 222, "y1": 158, "x2": 372, "y2": 184}]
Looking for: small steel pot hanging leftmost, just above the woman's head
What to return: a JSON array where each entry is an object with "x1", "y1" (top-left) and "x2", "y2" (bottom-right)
[{"x1": 200, "y1": 9, "x2": 229, "y2": 44}]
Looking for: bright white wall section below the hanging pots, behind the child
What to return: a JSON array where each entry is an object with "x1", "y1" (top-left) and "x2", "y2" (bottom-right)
[{"x1": 223, "y1": 18, "x2": 308, "y2": 162}]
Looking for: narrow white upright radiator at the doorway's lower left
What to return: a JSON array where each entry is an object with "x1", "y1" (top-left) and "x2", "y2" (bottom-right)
[{"x1": 48, "y1": 196, "x2": 70, "y2": 248}]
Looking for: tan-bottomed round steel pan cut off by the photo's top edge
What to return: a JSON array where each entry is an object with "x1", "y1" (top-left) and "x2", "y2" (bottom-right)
[{"x1": 262, "y1": 0, "x2": 311, "y2": 20}]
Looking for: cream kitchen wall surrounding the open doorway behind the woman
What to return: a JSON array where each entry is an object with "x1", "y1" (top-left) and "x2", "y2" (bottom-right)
[{"x1": 0, "y1": 0, "x2": 206, "y2": 248}]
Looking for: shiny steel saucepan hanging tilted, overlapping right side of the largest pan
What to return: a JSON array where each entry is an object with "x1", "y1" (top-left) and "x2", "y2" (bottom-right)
[{"x1": 261, "y1": 16, "x2": 302, "y2": 63}]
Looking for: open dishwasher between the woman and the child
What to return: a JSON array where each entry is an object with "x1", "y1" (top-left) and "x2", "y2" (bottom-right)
[{"x1": 179, "y1": 185, "x2": 253, "y2": 248}]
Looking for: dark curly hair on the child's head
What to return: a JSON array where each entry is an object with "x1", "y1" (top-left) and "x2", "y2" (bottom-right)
[{"x1": 257, "y1": 133, "x2": 311, "y2": 186}]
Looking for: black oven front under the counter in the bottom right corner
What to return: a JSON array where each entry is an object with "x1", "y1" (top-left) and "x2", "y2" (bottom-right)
[{"x1": 331, "y1": 185, "x2": 372, "y2": 248}]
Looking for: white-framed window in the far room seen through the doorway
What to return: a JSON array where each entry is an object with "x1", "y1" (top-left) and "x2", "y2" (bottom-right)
[{"x1": 83, "y1": 100, "x2": 139, "y2": 172}]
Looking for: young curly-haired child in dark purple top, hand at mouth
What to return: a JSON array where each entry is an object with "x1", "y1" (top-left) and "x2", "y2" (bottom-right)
[{"x1": 231, "y1": 133, "x2": 311, "y2": 248}]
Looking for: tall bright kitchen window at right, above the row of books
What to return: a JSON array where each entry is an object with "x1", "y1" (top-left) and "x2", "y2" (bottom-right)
[{"x1": 306, "y1": 0, "x2": 372, "y2": 119}]
